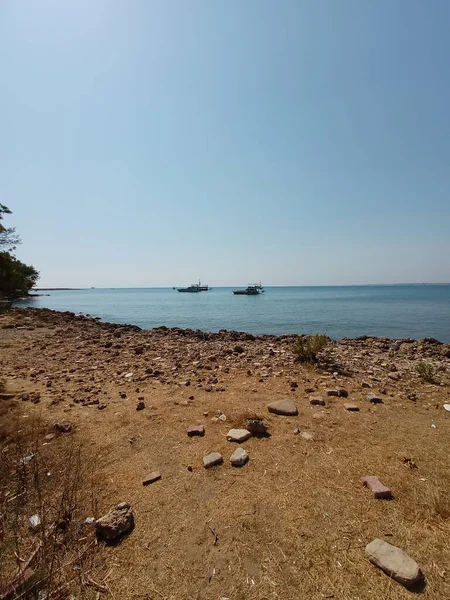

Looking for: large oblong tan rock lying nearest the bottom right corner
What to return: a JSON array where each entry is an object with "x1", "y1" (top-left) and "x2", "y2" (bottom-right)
[{"x1": 366, "y1": 539, "x2": 424, "y2": 587}]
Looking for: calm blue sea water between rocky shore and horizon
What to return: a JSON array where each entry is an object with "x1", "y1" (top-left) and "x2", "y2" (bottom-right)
[{"x1": 15, "y1": 285, "x2": 450, "y2": 342}]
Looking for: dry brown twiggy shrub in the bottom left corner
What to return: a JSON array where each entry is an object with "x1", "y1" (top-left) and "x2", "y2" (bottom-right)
[{"x1": 0, "y1": 410, "x2": 103, "y2": 600}]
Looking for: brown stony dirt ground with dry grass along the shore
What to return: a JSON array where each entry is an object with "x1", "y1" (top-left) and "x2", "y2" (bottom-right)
[{"x1": 0, "y1": 309, "x2": 450, "y2": 600}]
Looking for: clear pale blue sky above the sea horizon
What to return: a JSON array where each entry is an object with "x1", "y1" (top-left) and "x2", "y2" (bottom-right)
[{"x1": 0, "y1": 0, "x2": 450, "y2": 287}]
